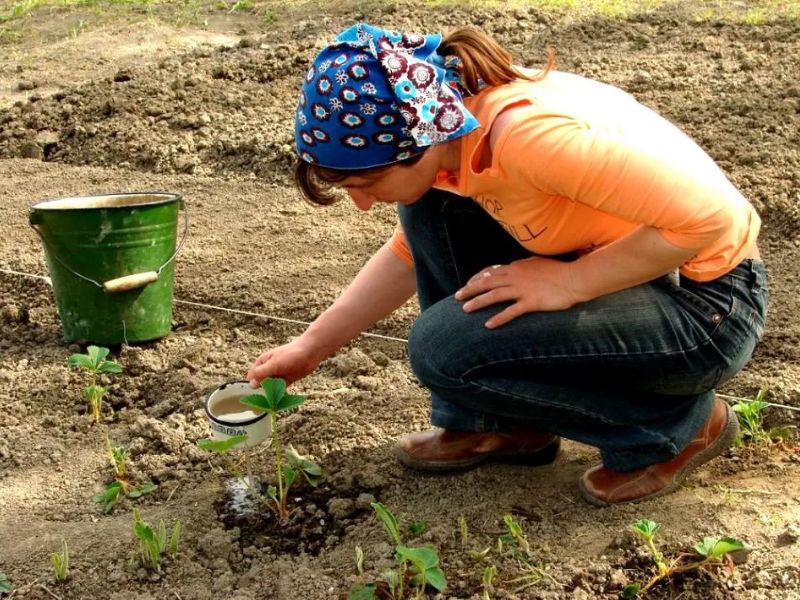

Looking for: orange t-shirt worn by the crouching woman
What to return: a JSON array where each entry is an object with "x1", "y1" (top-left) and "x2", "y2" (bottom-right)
[{"x1": 390, "y1": 72, "x2": 761, "y2": 281}]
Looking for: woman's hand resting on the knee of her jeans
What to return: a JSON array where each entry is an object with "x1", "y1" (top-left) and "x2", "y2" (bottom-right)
[{"x1": 455, "y1": 256, "x2": 579, "y2": 329}]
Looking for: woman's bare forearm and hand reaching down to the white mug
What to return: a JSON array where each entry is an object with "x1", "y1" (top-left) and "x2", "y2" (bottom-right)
[{"x1": 247, "y1": 244, "x2": 416, "y2": 387}]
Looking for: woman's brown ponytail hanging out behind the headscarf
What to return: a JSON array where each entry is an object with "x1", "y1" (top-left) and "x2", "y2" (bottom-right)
[{"x1": 437, "y1": 28, "x2": 556, "y2": 94}]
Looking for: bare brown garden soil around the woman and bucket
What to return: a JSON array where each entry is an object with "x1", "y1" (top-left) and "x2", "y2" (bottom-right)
[{"x1": 0, "y1": 4, "x2": 800, "y2": 600}]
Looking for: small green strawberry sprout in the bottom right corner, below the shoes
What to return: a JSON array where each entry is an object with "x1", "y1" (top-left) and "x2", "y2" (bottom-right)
[{"x1": 622, "y1": 519, "x2": 745, "y2": 599}]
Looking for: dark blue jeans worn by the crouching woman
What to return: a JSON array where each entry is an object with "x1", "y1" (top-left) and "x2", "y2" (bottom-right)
[{"x1": 398, "y1": 190, "x2": 767, "y2": 471}]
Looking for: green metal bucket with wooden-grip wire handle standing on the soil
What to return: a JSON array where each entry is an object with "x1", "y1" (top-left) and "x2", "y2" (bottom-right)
[{"x1": 29, "y1": 192, "x2": 189, "y2": 344}]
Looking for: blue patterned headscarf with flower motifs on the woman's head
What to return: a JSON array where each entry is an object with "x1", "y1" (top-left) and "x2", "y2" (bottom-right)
[{"x1": 295, "y1": 23, "x2": 478, "y2": 169}]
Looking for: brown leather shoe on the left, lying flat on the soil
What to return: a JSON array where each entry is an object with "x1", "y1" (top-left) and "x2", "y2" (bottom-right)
[{"x1": 395, "y1": 429, "x2": 561, "y2": 472}]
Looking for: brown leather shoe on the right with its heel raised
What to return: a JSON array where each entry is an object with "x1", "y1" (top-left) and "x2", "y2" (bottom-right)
[{"x1": 580, "y1": 398, "x2": 739, "y2": 506}]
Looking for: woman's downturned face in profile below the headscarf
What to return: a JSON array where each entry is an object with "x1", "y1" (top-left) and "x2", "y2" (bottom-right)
[{"x1": 336, "y1": 146, "x2": 450, "y2": 210}]
